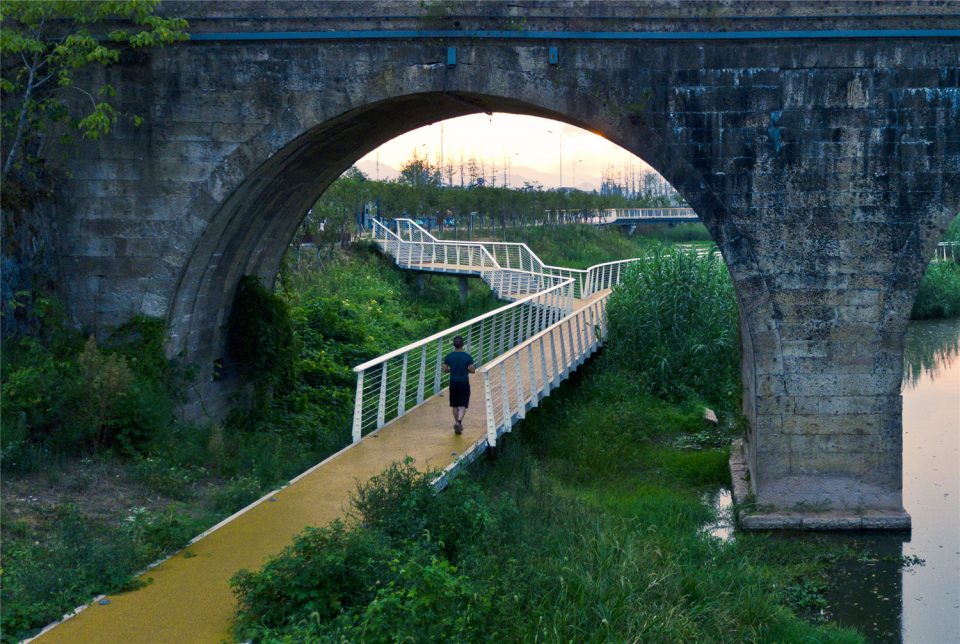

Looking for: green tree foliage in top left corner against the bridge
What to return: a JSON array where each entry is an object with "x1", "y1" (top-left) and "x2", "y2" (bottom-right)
[{"x1": 0, "y1": 0, "x2": 187, "y2": 186}]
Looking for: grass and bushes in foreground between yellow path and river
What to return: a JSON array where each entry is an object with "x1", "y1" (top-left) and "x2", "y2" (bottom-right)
[{"x1": 233, "y1": 443, "x2": 862, "y2": 642}]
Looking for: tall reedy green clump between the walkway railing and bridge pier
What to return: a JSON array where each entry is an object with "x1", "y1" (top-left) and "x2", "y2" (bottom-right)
[{"x1": 606, "y1": 247, "x2": 740, "y2": 407}]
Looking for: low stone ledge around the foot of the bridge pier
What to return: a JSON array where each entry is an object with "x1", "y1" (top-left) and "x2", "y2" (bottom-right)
[{"x1": 730, "y1": 440, "x2": 910, "y2": 530}]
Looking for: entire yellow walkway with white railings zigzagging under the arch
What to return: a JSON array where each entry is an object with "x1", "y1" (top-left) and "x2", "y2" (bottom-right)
[{"x1": 36, "y1": 221, "x2": 635, "y2": 644}]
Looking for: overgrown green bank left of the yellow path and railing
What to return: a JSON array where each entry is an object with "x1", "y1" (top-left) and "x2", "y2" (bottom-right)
[{"x1": 0, "y1": 245, "x2": 499, "y2": 642}]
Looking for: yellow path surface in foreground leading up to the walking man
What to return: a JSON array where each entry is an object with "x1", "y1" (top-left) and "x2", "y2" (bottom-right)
[{"x1": 36, "y1": 380, "x2": 485, "y2": 644}]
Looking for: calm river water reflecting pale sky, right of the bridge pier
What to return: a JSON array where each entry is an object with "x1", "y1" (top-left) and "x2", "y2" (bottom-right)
[{"x1": 830, "y1": 320, "x2": 960, "y2": 644}]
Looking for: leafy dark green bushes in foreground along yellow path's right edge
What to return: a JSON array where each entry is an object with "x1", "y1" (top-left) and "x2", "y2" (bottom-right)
[{"x1": 232, "y1": 460, "x2": 505, "y2": 641}]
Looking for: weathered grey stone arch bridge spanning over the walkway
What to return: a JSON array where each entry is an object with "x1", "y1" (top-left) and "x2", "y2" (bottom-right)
[{"x1": 57, "y1": 0, "x2": 960, "y2": 526}]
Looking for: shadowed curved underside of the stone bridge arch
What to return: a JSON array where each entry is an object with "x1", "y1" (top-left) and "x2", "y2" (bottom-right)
[{"x1": 168, "y1": 92, "x2": 736, "y2": 366}]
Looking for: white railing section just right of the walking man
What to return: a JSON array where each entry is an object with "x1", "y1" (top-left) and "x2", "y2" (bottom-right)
[{"x1": 477, "y1": 293, "x2": 609, "y2": 447}]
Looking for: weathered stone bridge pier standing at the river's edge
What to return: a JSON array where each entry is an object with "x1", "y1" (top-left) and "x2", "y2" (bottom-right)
[{"x1": 710, "y1": 191, "x2": 948, "y2": 529}]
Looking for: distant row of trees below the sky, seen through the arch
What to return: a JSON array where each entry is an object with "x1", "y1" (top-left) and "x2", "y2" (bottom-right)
[{"x1": 293, "y1": 155, "x2": 678, "y2": 244}]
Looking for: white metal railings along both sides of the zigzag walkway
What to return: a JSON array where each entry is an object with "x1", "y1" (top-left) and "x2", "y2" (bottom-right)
[{"x1": 353, "y1": 219, "x2": 676, "y2": 445}]
